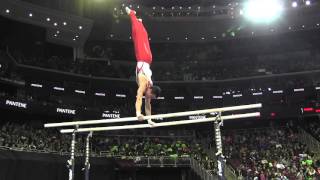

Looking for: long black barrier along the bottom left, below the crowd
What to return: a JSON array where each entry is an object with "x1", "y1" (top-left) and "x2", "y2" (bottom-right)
[{"x1": 0, "y1": 150, "x2": 200, "y2": 180}]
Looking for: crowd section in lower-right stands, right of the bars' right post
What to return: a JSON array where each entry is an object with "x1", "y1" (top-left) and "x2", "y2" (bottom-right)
[{"x1": 224, "y1": 127, "x2": 316, "y2": 179}]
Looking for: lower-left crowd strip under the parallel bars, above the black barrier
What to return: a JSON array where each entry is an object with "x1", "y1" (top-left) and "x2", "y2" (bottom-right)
[{"x1": 0, "y1": 122, "x2": 216, "y2": 170}]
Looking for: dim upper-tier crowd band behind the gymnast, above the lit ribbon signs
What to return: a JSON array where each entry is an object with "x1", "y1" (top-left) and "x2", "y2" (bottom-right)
[{"x1": 5, "y1": 45, "x2": 320, "y2": 81}]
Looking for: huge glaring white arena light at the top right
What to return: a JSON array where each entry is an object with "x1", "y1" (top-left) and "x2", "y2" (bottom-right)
[{"x1": 243, "y1": 0, "x2": 283, "y2": 23}]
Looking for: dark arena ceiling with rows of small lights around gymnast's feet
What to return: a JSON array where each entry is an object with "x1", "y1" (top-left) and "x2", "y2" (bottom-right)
[{"x1": 7, "y1": 0, "x2": 320, "y2": 43}]
